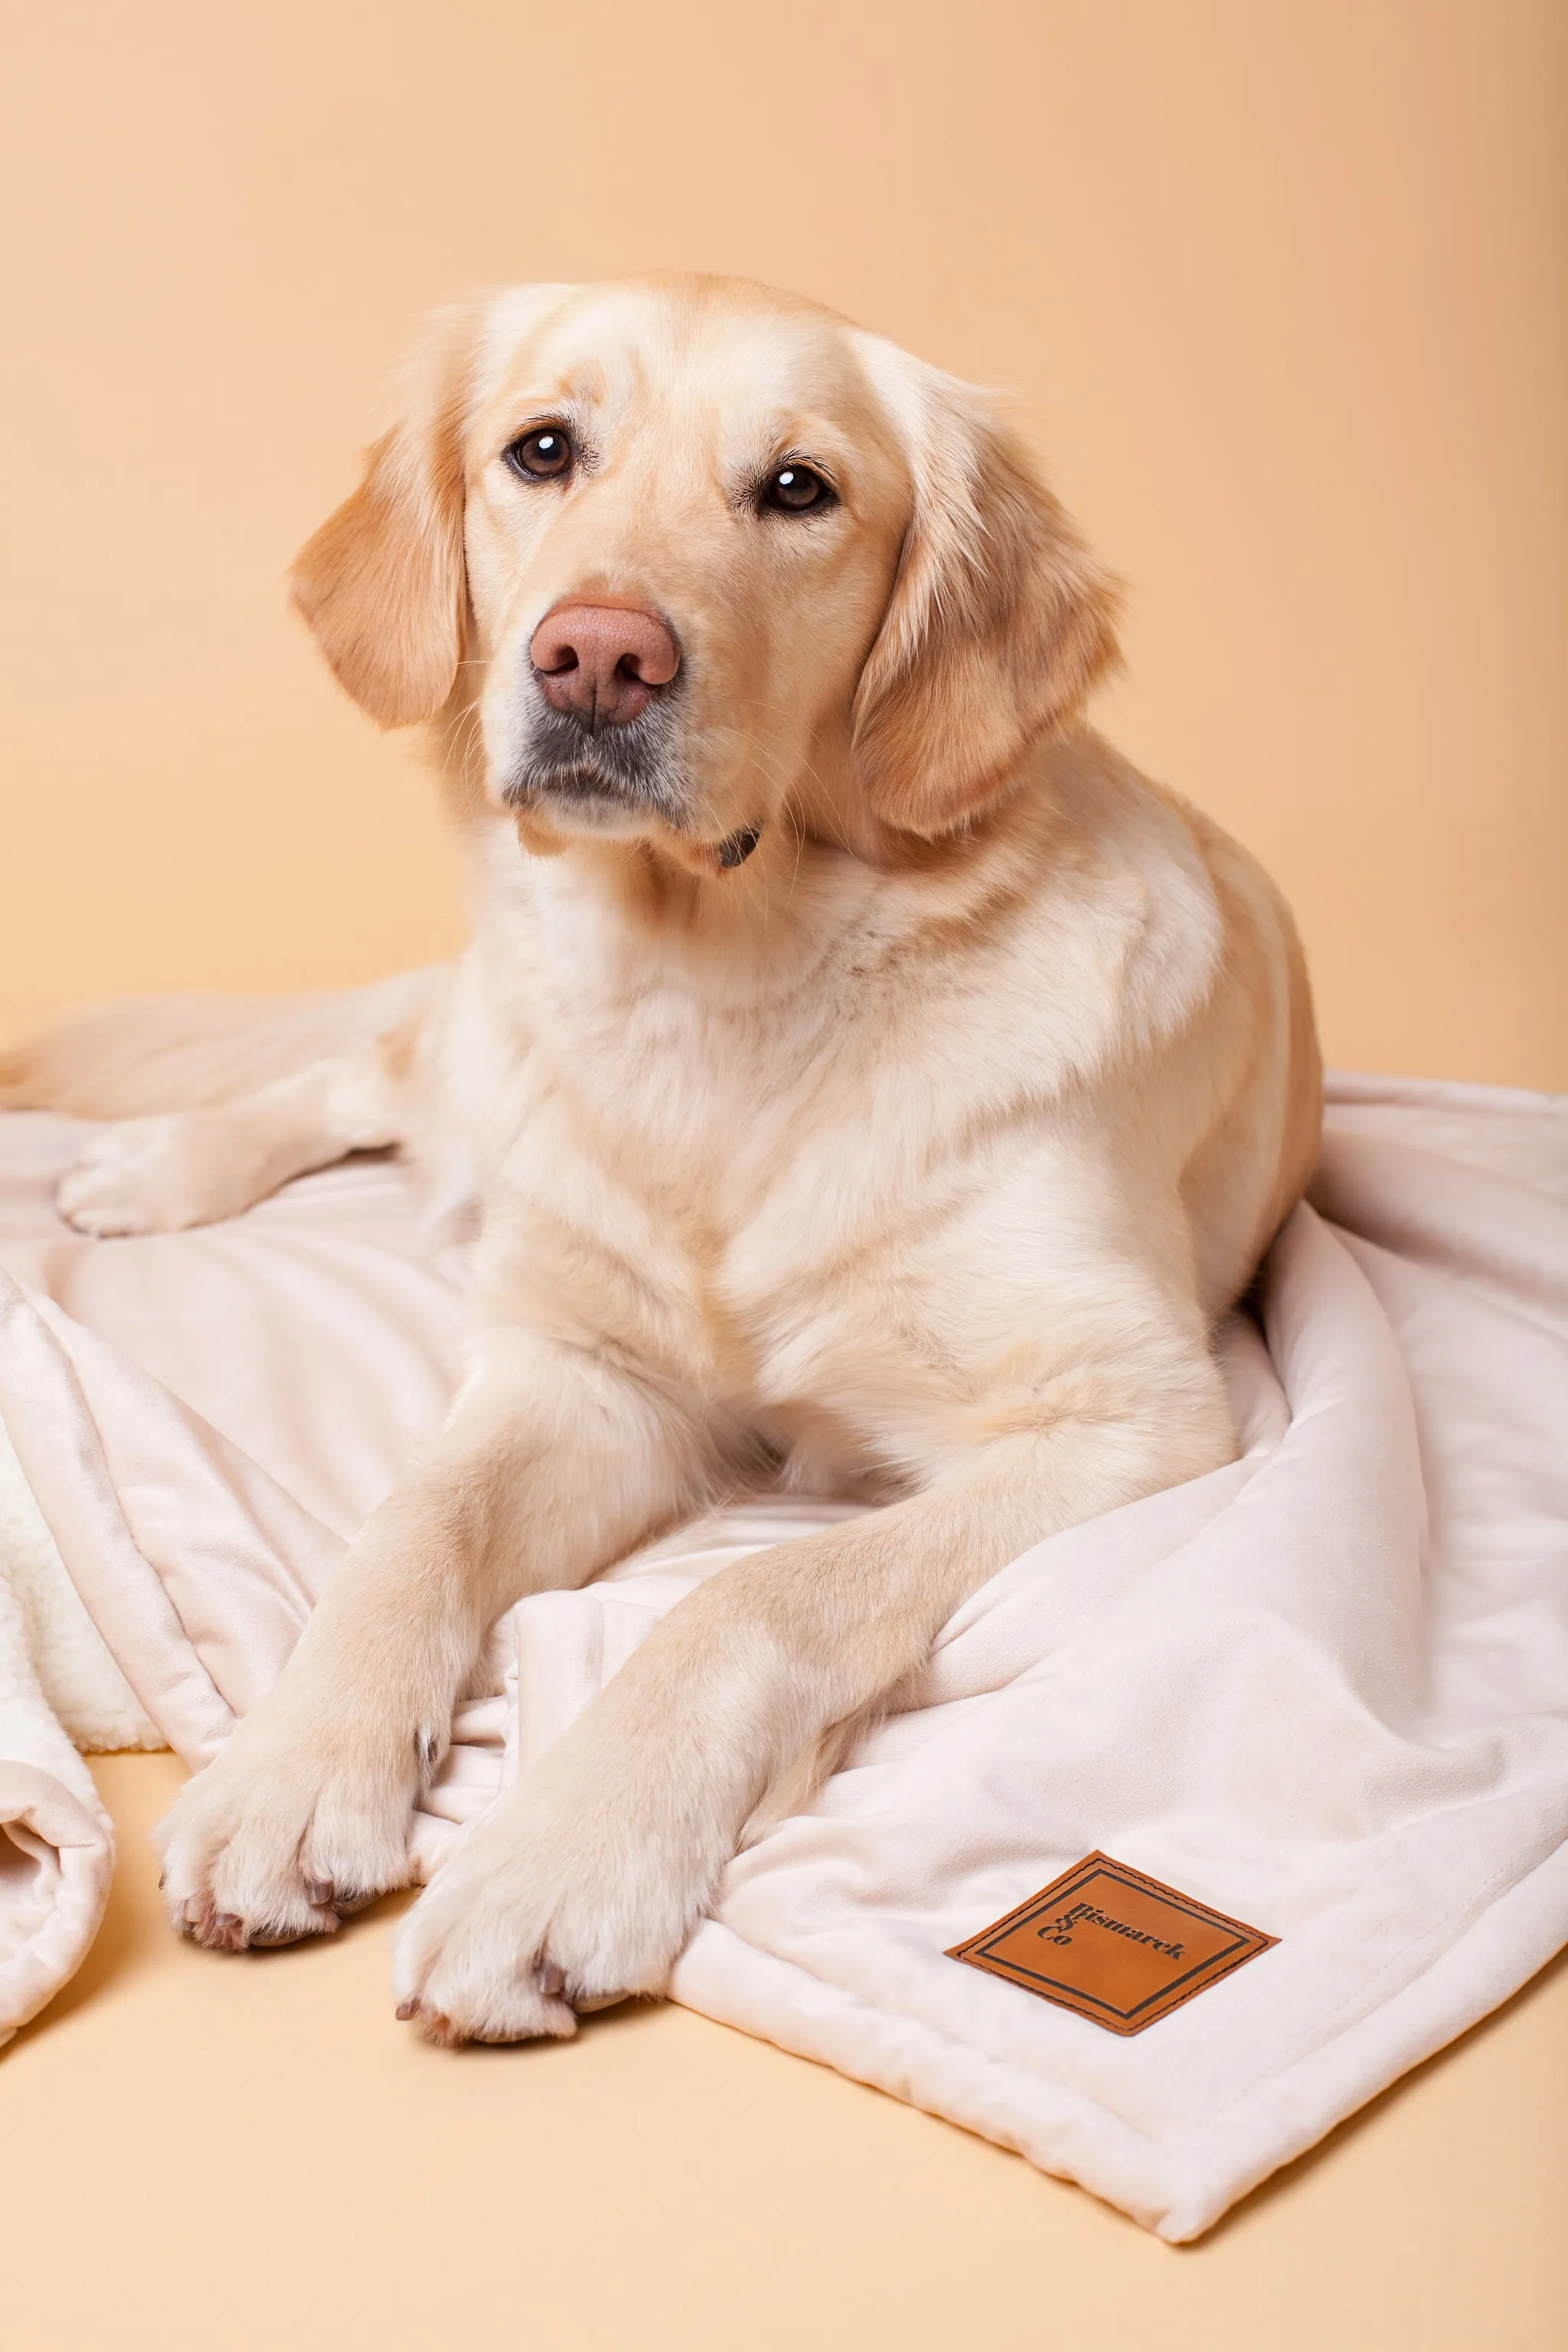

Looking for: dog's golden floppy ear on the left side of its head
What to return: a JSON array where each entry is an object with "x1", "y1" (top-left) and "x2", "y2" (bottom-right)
[{"x1": 289, "y1": 303, "x2": 482, "y2": 727}]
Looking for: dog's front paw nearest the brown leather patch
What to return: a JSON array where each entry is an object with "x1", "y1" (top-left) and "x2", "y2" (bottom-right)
[{"x1": 393, "y1": 1769, "x2": 714, "y2": 2041}]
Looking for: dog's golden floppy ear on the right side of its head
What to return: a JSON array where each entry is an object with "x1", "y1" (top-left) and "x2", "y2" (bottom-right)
[{"x1": 854, "y1": 336, "x2": 1116, "y2": 835}]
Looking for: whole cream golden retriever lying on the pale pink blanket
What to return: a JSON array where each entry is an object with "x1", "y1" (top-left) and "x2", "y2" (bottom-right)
[{"x1": 5, "y1": 277, "x2": 1321, "y2": 2041}]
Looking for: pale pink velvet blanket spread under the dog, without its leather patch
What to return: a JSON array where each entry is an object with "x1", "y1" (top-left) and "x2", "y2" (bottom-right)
[{"x1": 0, "y1": 1077, "x2": 1568, "y2": 2239}]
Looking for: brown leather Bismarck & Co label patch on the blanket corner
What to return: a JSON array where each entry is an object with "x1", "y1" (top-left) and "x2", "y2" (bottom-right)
[{"x1": 947, "y1": 1854, "x2": 1279, "y2": 2034}]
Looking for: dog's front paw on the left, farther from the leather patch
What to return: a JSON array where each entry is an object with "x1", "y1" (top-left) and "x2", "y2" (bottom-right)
[{"x1": 158, "y1": 1696, "x2": 435, "y2": 1952}]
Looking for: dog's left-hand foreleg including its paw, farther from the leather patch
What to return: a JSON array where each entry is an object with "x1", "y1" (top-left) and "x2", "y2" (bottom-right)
[{"x1": 160, "y1": 1331, "x2": 705, "y2": 1950}]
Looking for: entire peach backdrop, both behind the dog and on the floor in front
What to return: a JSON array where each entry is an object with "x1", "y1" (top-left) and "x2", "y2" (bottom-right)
[{"x1": 0, "y1": 0, "x2": 1568, "y2": 2352}]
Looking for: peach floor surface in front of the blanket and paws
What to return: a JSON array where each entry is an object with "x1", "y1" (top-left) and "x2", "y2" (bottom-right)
[{"x1": 0, "y1": 1757, "x2": 1568, "y2": 2352}]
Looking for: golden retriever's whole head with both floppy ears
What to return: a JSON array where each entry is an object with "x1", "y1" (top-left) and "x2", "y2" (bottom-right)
[{"x1": 294, "y1": 277, "x2": 1114, "y2": 873}]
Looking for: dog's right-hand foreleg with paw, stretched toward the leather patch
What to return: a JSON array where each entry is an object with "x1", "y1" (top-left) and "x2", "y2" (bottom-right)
[{"x1": 397, "y1": 1362, "x2": 1234, "y2": 2039}]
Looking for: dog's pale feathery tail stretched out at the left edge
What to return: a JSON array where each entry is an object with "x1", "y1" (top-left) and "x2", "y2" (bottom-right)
[{"x1": 0, "y1": 965, "x2": 449, "y2": 1119}]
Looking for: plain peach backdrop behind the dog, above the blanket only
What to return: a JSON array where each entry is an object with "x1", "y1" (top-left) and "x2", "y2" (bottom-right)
[{"x1": 0, "y1": 0, "x2": 1568, "y2": 1084}]
